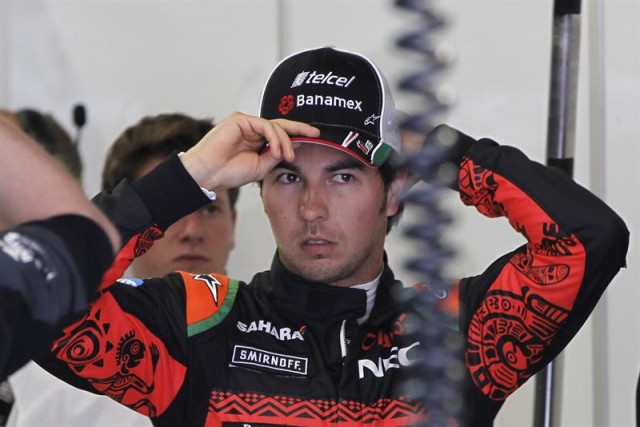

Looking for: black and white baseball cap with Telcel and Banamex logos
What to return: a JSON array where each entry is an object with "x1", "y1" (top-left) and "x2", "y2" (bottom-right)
[{"x1": 260, "y1": 47, "x2": 400, "y2": 167}]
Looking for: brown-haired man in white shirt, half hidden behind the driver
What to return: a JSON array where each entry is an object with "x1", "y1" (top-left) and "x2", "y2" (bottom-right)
[{"x1": 7, "y1": 113, "x2": 239, "y2": 427}]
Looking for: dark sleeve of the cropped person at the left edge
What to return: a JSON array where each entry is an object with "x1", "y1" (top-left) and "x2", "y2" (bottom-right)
[{"x1": 0, "y1": 215, "x2": 113, "y2": 381}]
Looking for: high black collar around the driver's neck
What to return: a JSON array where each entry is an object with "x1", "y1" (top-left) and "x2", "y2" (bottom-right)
[{"x1": 264, "y1": 252, "x2": 402, "y2": 325}]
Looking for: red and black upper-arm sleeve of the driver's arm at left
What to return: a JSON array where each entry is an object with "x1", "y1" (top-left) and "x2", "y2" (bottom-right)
[{"x1": 44, "y1": 279, "x2": 186, "y2": 417}]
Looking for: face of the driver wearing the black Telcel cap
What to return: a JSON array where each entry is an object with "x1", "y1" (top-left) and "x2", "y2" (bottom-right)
[{"x1": 262, "y1": 143, "x2": 398, "y2": 286}]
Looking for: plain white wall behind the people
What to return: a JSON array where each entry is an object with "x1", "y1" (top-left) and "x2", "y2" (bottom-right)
[{"x1": 0, "y1": 0, "x2": 640, "y2": 426}]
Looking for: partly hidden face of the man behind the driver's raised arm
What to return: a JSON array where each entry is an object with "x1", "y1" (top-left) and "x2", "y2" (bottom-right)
[{"x1": 131, "y1": 158, "x2": 236, "y2": 278}]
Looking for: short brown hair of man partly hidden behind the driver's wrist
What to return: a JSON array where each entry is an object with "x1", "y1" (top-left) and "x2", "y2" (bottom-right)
[{"x1": 102, "y1": 113, "x2": 239, "y2": 209}]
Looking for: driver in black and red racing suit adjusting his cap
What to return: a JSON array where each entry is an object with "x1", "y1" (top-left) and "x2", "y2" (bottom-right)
[{"x1": 36, "y1": 48, "x2": 628, "y2": 426}]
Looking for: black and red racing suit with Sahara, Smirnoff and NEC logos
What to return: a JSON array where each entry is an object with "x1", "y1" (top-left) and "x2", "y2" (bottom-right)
[{"x1": 40, "y1": 125, "x2": 628, "y2": 426}]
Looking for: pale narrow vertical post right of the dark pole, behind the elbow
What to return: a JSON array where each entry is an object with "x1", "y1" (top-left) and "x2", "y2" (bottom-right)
[{"x1": 587, "y1": 0, "x2": 610, "y2": 426}]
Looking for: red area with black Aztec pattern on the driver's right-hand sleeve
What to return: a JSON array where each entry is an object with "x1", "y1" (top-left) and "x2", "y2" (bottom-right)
[{"x1": 459, "y1": 158, "x2": 586, "y2": 400}]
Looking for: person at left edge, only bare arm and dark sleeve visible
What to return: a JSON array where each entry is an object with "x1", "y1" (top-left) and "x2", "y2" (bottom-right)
[{"x1": 0, "y1": 118, "x2": 120, "y2": 381}]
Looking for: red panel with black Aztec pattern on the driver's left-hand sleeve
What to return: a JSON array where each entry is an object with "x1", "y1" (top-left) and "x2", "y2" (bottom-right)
[{"x1": 53, "y1": 285, "x2": 186, "y2": 417}]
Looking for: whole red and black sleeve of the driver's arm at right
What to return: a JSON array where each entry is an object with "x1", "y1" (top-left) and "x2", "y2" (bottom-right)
[{"x1": 458, "y1": 140, "x2": 628, "y2": 401}]
